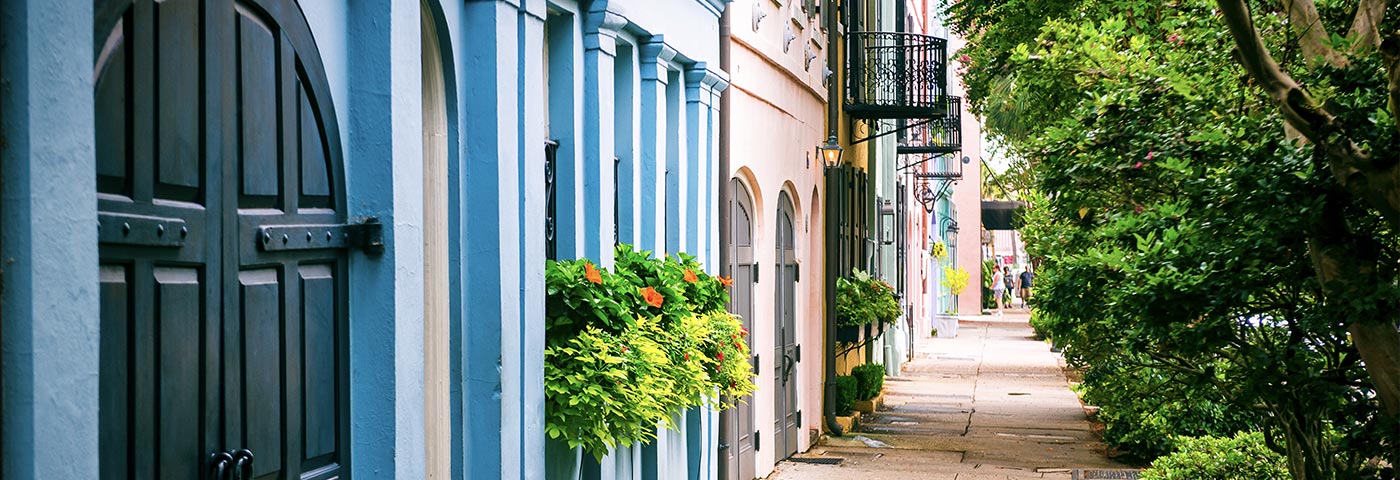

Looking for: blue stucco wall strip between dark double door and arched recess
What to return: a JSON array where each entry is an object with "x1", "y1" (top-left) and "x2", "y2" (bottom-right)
[{"x1": 302, "y1": 0, "x2": 426, "y2": 479}]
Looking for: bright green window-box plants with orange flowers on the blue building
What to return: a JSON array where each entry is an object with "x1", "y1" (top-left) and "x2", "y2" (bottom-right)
[{"x1": 545, "y1": 245, "x2": 755, "y2": 459}]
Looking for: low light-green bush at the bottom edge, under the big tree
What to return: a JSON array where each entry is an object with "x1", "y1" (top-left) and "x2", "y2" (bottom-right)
[{"x1": 1140, "y1": 432, "x2": 1291, "y2": 480}]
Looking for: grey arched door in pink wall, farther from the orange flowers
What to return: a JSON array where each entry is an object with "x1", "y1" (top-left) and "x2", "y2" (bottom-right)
[{"x1": 773, "y1": 190, "x2": 802, "y2": 462}]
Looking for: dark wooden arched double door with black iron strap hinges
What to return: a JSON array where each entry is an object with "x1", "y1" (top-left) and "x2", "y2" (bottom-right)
[{"x1": 94, "y1": 0, "x2": 350, "y2": 480}]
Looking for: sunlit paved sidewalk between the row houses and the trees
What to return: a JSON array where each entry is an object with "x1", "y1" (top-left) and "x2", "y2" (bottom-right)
[{"x1": 769, "y1": 312, "x2": 1127, "y2": 480}]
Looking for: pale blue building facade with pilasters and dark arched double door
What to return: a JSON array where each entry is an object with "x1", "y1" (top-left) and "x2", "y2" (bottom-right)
[{"x1": 0, "y1": 0, "x2": 728, "y2": 479}]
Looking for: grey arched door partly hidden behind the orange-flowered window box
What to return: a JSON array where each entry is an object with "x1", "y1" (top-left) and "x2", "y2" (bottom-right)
[{"x1": 718, "y1": 179, "x2": 757, "y2": 480}]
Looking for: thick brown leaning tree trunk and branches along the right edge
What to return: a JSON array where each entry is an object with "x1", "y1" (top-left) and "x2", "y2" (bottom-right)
[{"x1": 1217, "y1": 0, "x2": 1400, "y2": 417}]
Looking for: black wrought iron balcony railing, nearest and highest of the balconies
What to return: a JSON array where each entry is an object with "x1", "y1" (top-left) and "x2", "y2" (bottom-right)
[{"x1": 846, "y1": 32, "x2": 948, "y2": 119}]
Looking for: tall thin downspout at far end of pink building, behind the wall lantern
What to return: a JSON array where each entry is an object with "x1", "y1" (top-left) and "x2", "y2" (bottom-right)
[{"x1": 817, "y1": 0, "x2": 846, "y2": 437}]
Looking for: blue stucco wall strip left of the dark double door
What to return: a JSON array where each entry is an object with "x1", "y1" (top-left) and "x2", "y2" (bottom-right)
[{"x1": 0, "y1": 0, "x2": 99, "y2": 479}]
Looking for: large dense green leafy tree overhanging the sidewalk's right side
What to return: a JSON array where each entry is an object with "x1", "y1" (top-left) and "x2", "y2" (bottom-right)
[{"x1": 951, "y1": 0, "x2": 1400, "y2": 479}]
